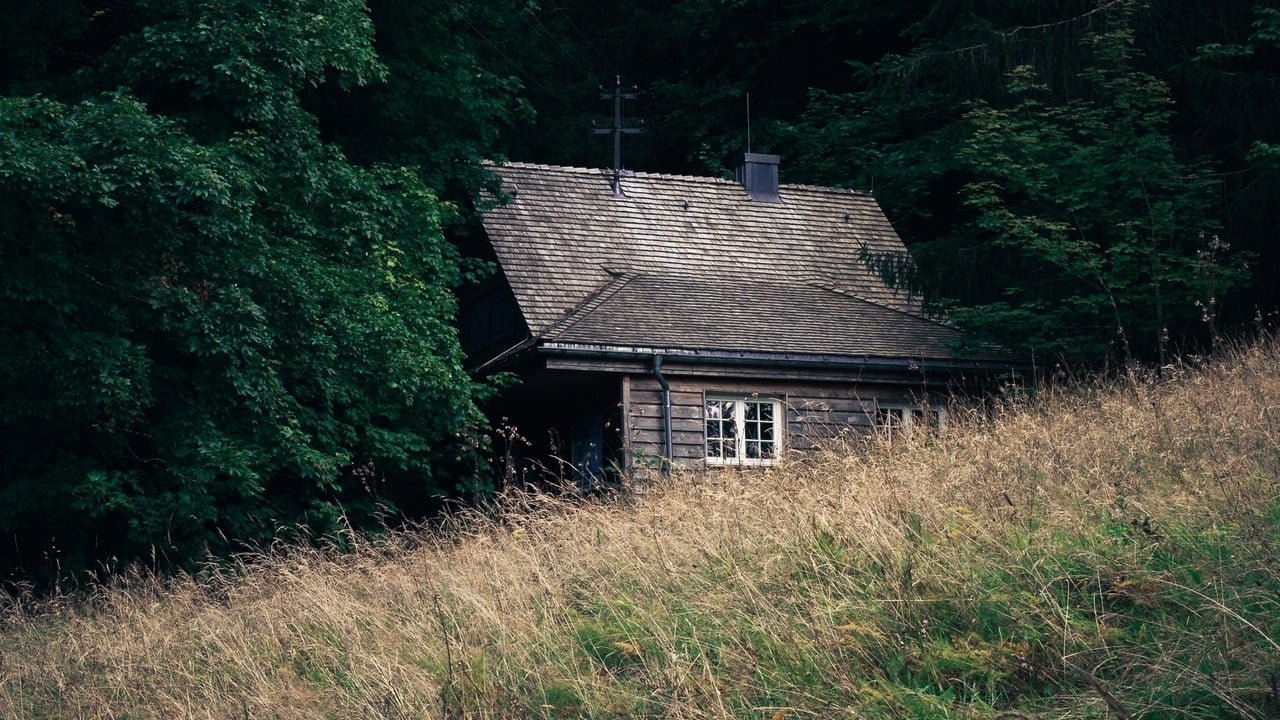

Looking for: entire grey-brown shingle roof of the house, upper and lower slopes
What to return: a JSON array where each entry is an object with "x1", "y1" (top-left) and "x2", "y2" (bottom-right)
[{"x1": 484, "y1": 163, "x2": 998, "y2": 359}]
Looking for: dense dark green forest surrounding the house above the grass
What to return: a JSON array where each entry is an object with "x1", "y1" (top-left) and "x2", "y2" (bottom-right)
[{"x1": 0, "y1": 0, "x2": 1280, "y2": 582}]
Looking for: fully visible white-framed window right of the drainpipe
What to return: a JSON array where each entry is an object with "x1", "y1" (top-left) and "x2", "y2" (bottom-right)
[{"x1": 704, "y1": 393, "x2": 786, "y2": 465}]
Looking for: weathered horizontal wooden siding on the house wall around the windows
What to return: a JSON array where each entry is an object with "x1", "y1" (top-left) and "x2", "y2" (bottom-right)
[{"x1": 623, "y1": 375, "x2": 936, "y2": 466}]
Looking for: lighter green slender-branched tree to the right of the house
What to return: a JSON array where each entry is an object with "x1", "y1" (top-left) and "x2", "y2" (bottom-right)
[{"x1": 954, "y1": 13, "x2": 1243, "y2": 359}]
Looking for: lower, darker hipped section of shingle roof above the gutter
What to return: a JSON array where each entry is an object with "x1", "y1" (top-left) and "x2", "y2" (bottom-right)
[{"x1": 543, "y1": 277, "x2": 1007, "y2": 361}]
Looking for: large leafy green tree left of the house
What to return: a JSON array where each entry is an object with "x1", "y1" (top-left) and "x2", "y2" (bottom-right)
[{"x1": 0, "y1": 0, "x2": 480, "y2": 573}]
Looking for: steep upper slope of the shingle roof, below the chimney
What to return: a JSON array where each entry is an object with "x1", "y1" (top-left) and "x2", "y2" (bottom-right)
[{"x1": 484, "y1": 164, "x2": 920, "y2": 336}]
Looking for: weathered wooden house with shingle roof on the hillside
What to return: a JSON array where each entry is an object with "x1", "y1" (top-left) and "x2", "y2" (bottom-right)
[{"x1": 462, "y1": 154, "x2": 1012, "y2": 482}]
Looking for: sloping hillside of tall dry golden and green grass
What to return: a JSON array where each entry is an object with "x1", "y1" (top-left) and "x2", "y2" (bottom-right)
[{"x1": 0, "y1": 342, "x2": 1280, "y2": 720}]
